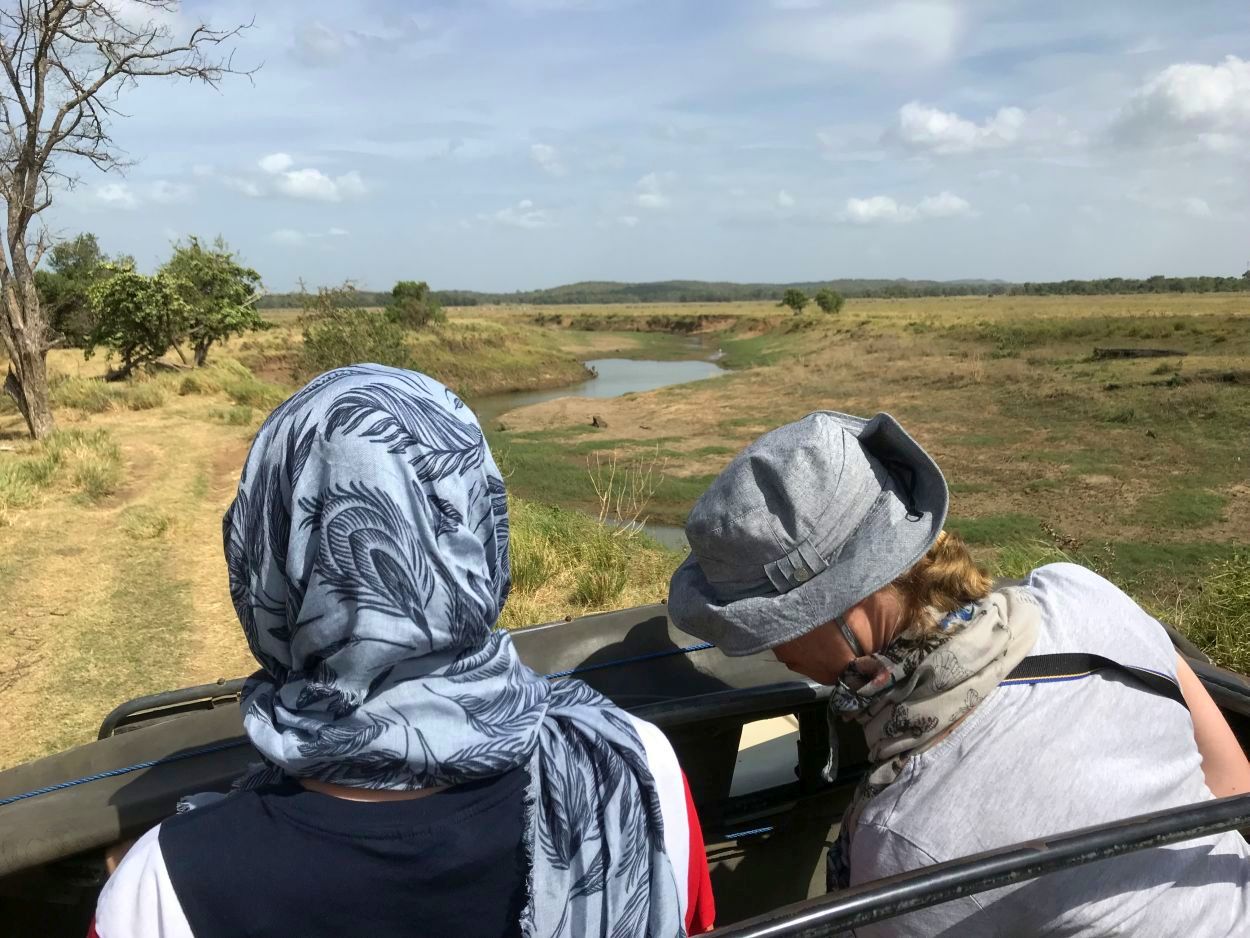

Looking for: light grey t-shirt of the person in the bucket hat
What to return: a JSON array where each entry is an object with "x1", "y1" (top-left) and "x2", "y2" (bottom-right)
[{"x1": 850, "y1": 564, "x2": 1250, "y2": 938}]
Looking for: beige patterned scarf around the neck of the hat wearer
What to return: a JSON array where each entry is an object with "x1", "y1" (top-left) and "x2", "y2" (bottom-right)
[{"x1": 826, "y1": 587, "x2": 1041, "y2": 889}]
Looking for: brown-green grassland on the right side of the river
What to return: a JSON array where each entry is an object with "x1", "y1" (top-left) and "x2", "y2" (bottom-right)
[{"x1": 494, "y1": 295, "x2": 1250, "y2": 640}]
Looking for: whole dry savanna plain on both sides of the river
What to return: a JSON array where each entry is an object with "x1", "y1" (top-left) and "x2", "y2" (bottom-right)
[{"x1": 0, "y1": 294, "x2": 1250, "y2": 767}]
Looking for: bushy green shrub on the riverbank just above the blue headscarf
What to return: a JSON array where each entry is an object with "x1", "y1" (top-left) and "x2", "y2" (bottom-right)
[{"x1": 293, "y1": 284, "x2": 415, "y2": 380}]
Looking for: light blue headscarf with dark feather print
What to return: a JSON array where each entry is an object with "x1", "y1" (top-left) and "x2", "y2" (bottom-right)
[{"x1": 224, "y1": 365, "x2": 683, "y2": 938}]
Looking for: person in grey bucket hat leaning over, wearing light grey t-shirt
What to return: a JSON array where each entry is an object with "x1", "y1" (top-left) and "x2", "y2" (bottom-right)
[{"x1": 669, "y1": 411, "x2": 1250, "y2": 938}]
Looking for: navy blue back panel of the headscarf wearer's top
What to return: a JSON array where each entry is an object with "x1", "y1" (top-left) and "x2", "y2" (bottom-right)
[{"x1": 159, "y1": 769, "x2": 528, "y2": 938}]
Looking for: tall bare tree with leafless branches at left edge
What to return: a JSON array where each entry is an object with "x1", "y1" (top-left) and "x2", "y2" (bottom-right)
[{"x1": 0, "y1": 0, "x2": 246, "y2": 439}]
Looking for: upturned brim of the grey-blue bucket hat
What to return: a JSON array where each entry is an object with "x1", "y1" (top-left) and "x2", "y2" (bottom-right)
[{"x1": 669, "y1": 411, "x2": 950, "y2": 657}]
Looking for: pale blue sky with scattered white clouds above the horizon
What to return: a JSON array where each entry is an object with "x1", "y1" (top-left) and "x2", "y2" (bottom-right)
[{"x1": 48, "y1": 0, "x2": 1250, "y2": 291}]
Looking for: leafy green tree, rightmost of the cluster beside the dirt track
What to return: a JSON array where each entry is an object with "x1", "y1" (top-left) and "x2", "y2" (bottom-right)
[{"x1": 161, "y1": 236, "x2": 269, "y2": 366}]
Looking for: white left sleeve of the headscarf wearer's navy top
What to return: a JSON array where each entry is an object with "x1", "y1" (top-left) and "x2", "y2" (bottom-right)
[{"x1": 95, "y1": 825, "x2": 194, "y2": 938}]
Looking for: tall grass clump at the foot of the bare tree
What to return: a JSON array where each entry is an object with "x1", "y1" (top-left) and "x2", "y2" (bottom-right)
[{"x1": 0, "y1": 429, "x2": 123, "y2": 509}]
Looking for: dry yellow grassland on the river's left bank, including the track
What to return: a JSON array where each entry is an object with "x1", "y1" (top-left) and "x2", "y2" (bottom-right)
[{"x1": 0, "y1": 320, "x2": 678, "y2": 768}]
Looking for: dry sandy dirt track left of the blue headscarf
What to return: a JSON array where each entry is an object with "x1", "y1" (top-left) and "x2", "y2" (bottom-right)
[{"x1": 0, "y1": 399, "x2": 251, "y2": 768}]
